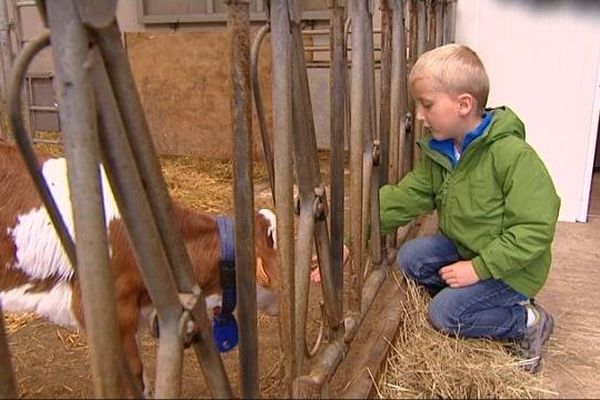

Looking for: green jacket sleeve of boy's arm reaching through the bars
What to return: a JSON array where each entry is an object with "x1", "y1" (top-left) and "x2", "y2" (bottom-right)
[{"x1": 379, "y1": 157, "x2": 435, "y2": 235}]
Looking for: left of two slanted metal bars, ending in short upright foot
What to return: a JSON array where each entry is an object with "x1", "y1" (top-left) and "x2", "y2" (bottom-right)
[{"x1": 93, "y1": 53, "x2": 183, "y2": 397}]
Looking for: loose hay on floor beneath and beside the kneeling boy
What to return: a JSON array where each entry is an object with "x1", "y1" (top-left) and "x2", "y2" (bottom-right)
[{"x1": 376, "y1": 276, "x2": 555, "y2": 399}]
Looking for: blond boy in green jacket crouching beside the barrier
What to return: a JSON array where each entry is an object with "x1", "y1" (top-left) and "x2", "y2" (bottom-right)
[{"x1": 380, "y1": 44, "x2": 560, "y2": 372}]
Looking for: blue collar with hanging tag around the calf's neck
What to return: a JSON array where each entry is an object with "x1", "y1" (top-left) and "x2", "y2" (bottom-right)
[{"x1": 213, "y1": 216, "x2": 238, "y2": 353}]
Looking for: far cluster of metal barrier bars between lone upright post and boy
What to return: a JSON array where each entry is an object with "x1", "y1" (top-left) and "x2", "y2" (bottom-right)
[{"x1": 251, "y1": 0, "x2": 455, "y2": 398}]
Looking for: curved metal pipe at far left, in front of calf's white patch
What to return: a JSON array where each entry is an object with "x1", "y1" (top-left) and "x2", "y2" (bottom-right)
[{"x1": 8, "y1": 32, "x2": 77, "y2": 268}]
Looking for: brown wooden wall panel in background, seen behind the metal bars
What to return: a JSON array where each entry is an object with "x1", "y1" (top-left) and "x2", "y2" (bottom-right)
[{"x1": 125, "y1": 32, "x2": 272, "y2": 158}]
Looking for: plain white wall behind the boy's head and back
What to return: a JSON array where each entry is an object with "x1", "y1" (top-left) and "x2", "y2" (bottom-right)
[{"x1": 457, "y1": 0, "x2": 600, "y2": 221}]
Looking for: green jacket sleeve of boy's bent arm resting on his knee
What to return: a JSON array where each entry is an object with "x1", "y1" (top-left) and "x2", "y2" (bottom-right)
[{"x1": 473, "y1": 147, "x2": 560, "y2": 279}]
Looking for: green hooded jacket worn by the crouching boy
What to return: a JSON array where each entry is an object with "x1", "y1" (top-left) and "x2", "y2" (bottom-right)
[{"x1": 380, "y1": 107, "x2": 560, "y2": 297}]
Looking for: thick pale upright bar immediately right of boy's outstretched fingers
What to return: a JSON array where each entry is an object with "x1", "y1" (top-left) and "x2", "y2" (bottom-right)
[{"x1": 349, "y1": 0, "x2": 371, "y2": 313}]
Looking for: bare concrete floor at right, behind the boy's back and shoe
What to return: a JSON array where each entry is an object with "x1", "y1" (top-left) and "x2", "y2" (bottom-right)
[{"x1": 537, "y1": 173, "x2": 600, "y2": 398}]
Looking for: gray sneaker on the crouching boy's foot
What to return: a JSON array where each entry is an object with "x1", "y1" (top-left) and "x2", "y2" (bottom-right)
[{"x1": 518, "y1": 302, "x2": 554, "y2": 373}]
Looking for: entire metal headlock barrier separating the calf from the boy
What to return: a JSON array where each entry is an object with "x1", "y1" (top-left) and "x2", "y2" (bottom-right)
[{"x1": 0, "y1": 0, "x2": 455, "y2": 398}]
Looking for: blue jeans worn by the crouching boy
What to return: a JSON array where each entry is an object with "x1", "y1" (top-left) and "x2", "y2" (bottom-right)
[{"x1": 396, "y1": 235, "x2": 527, "y2": 339}]
